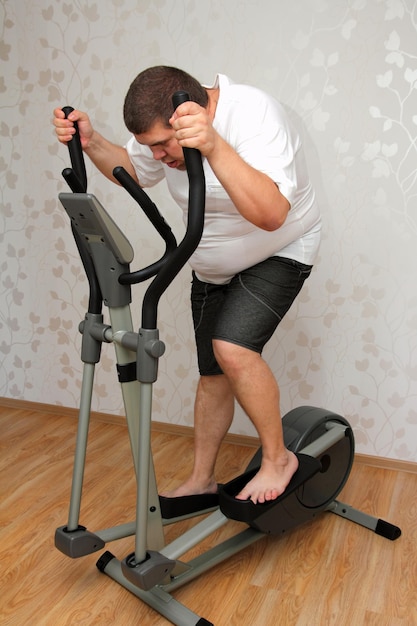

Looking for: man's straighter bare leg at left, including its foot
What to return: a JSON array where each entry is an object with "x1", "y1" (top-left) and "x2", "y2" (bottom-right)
[{"x1": 161, "y1": 375, "x2": 234, "y2": 498}]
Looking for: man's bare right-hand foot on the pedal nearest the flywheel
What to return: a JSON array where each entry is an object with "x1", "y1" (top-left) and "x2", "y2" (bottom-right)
[{"x1": 236, "y1": 450, "x2": 298, "y2": 504}]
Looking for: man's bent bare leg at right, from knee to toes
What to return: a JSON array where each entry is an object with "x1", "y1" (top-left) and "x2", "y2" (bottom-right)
[{"x1": 213, "y1": 339, "x2": 298, "y2": 503}]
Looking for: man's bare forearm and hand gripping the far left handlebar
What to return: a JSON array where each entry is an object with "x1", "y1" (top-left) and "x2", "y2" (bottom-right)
[{"x1": 53, "y1": 109, "x2": 138, "y2": 184}]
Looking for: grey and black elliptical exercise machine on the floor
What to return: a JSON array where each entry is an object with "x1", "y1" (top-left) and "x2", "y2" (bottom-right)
[{"x1": 55, "y1": 92, "x2": 401, "y2": 626}]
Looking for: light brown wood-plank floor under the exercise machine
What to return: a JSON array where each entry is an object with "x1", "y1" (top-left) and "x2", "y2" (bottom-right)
[{"x1": 0, "y1": 407, "x2": 417, "y2": 626}]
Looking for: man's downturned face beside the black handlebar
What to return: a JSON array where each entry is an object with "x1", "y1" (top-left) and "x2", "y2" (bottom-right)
[{"x1": 135, "y1": 122, "x2": 186, "y2": 170}]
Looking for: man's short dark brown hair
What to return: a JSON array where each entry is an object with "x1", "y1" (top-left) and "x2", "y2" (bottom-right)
[{"x1": 123, "y1": 65, "x2": 208, "y2": 135}]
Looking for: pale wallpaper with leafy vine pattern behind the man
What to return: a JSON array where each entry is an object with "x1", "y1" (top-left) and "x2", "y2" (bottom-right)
[{"x1": 0, "y1": 0, "x2": 417, "y2": 461}]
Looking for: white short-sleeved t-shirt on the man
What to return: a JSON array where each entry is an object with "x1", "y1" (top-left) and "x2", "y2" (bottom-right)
[{"x1": 126, "y1": 74, "x2": 321, "y2": 284}]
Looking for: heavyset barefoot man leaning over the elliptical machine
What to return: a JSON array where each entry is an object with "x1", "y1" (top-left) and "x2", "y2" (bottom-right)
[{"x1": 54, "y1": 66, "x2": 320, "y2": 503}]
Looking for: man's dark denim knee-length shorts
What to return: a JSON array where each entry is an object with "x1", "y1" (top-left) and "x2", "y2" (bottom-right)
[{"x1": 191, "y1": 256, "x2": 312, "y2": 376}]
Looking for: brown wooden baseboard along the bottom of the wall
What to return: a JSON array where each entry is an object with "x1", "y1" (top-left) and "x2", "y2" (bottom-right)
[{"x1": 0, "y1": 397, "x2": 417, "y2": 474}]
